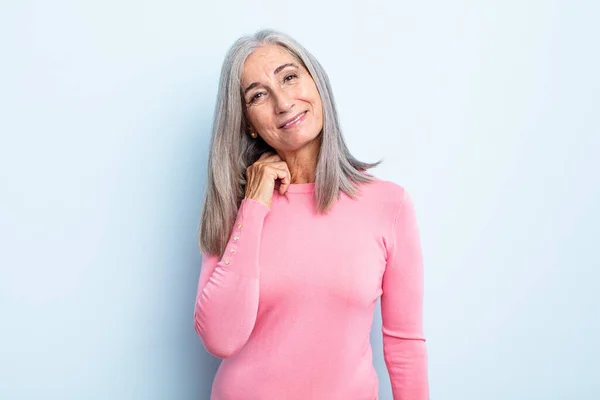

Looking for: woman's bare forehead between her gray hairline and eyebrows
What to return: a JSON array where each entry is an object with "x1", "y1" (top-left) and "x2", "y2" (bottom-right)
[{"x1": 242, "y1": 44, "x2": 300, "y2": 84}]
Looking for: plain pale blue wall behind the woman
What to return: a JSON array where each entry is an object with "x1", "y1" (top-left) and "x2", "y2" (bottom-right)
[{"x1": 0, "y1": 0, "x2": 600, "y2": 400}]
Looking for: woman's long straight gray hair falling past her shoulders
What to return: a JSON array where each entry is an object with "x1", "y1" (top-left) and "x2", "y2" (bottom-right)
[{"x1": 199, "y1": 29, "x2": 383, "y2": 256}]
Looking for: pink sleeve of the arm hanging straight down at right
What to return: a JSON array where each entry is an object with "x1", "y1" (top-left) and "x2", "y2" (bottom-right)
[{"x1": 381, "y1": 190, "x2": 429, "y2": 400}]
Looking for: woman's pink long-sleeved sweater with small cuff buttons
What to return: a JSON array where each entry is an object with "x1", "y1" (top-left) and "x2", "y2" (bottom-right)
[{"x1": 194, "y1": 179, "x2": 429, "y2": 400}]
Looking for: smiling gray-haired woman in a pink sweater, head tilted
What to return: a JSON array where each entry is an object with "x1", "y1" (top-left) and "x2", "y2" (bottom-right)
[{"x1": 194, "y1": 30, "x2": 429, "y2": 400}]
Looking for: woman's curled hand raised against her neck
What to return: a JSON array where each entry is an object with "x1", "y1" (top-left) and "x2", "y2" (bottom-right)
[{"x1": 245, "y1": 152, "x2": 291, "y2": 207}]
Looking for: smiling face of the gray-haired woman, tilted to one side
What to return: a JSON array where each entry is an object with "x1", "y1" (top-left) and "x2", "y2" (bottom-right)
[{"x1": 242, "y1": 45, "x2": 323, "y2": 152}]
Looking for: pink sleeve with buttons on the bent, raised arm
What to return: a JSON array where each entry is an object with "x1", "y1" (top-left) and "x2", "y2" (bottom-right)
[{"x1": 194, "y1": 198, "x2": 270, "y2": 358}]
